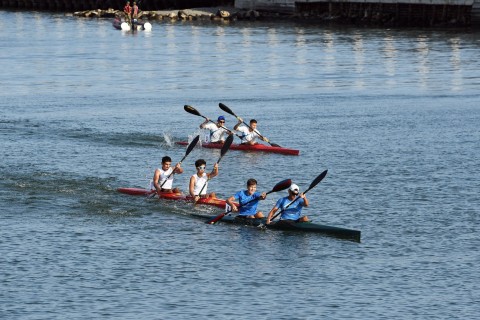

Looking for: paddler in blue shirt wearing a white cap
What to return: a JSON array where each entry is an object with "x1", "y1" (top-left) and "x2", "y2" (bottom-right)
[{"x1": 266, "y1": 183, "x2": 308, "y2": 224}]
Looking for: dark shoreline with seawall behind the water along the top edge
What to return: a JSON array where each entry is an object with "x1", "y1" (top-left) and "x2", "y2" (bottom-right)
[{"x1": 0, "y1": 0, "x2": 480, "y2": 27}]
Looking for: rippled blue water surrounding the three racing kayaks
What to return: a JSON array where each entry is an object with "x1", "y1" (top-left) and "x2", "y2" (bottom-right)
[{"x1": 0, "y1": 11, "x2": 480, "y2": 319}]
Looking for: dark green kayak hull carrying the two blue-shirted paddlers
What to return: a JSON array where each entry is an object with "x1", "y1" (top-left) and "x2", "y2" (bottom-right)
[{"x1": 193, "y1": 214, "x2": 361, "y2": 242}]
